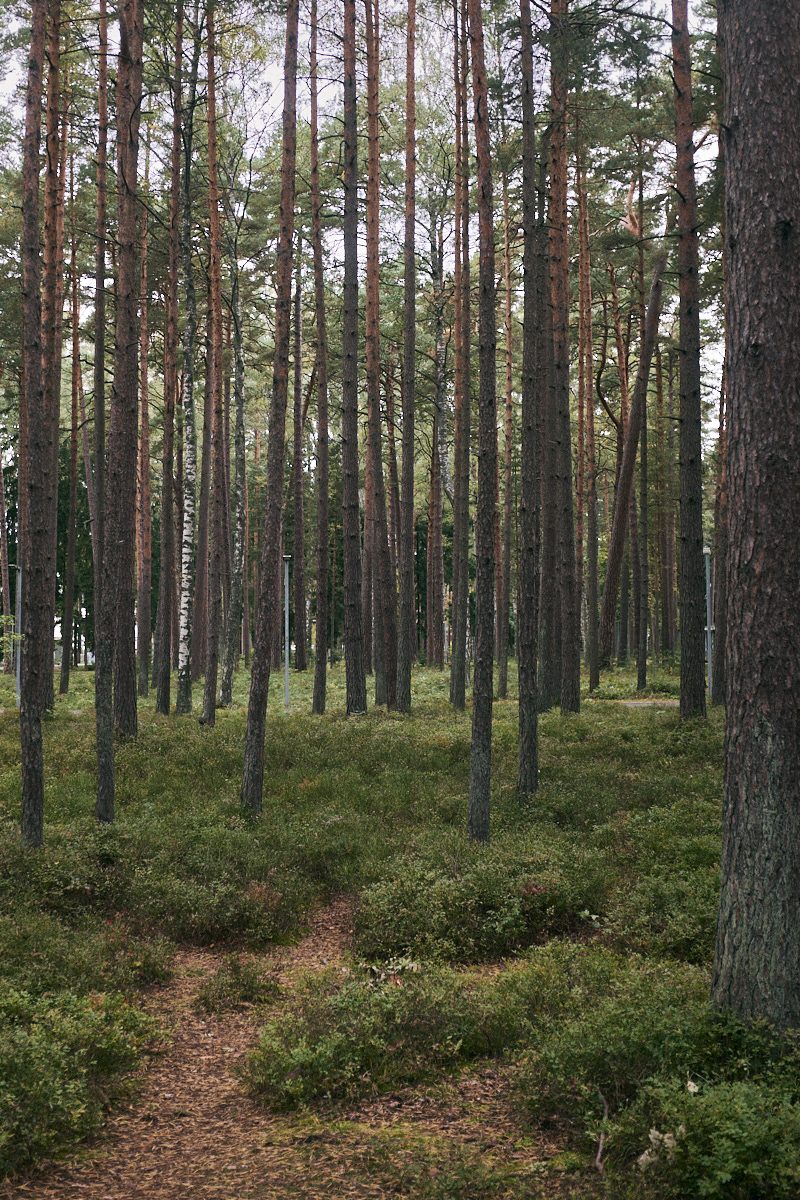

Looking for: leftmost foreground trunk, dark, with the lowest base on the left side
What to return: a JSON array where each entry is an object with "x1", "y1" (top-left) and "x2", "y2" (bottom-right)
[{"x1": 19, "y1": 0, "x2": 49, "y2": 846}]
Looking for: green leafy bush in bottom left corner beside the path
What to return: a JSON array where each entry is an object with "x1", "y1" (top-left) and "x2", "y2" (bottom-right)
[{"x1": 0, "y1": 988, "x2": 152, "y2": 1176}]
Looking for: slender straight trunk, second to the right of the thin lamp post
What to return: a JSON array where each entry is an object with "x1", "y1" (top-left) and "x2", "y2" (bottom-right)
[{"x1": 309, "y1": 0, "x2": 331, "y2": 713}]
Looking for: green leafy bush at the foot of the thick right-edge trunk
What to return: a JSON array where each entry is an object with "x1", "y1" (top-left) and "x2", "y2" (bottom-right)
[{"x1": 513, "y1": 947, "x2": 800, "y2": 1200}]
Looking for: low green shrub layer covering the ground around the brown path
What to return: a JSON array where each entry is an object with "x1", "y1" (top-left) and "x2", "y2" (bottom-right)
[{"x1": 0, "y1": 667, "x2": 738, "y2": 1196}]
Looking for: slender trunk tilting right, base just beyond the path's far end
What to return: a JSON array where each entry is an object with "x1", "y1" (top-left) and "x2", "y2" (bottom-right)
[{"x1": 241, "y1": 0, "x2": 299, "y2": 816}]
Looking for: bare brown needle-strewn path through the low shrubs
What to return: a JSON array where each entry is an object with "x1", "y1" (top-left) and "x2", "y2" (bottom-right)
[{"x1": 0, "y1": 899, "x2": 595, "y2": 1200}]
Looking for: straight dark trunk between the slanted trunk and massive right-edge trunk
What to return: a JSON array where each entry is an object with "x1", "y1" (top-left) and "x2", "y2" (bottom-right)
[{"x1": 672, "y1": 0, "x2": 705, "y2": 716}]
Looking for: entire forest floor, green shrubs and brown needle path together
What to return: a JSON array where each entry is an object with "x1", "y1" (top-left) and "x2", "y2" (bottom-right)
[{"x1": 0, "y1": 668, "x2": 777, "y2": 1200}]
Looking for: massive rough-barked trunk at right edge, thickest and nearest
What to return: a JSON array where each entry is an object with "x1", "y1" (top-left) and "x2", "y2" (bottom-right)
[{"x1": 712, "y1": 0, "x2": 800, "y2": 1027}]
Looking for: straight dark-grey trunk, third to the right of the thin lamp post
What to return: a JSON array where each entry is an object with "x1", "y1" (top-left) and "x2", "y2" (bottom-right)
[{"x1": 342, "y1": 0, "x2": 367, "y2": 714}]
